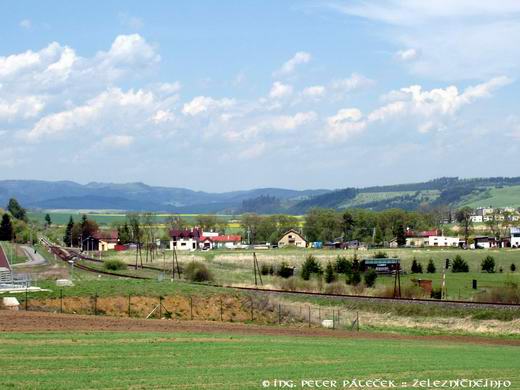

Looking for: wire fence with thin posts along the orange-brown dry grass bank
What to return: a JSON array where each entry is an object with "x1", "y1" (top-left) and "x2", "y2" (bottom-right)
[{"x1": 14, "y1": 289, "x2": 360, "y2": 330}]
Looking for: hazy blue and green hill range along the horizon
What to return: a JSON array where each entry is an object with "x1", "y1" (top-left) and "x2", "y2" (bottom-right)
[{"x1": 0, "y1": 177, "x2": 520, "y2": 214}]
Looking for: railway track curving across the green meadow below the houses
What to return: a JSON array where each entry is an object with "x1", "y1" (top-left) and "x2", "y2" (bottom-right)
[{"x1": 42, "y1": 239, "x2": 520, "y2": 310}]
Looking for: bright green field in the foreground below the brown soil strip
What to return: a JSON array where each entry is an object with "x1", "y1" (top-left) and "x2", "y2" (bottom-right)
[{"x1": 0, "y1": 332, "x2": 520, "y2": 390}]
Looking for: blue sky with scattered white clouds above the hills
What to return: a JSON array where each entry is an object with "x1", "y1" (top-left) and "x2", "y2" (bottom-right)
[{"x1": 0, "y1": 0, "x2": 520, "y2": 191}]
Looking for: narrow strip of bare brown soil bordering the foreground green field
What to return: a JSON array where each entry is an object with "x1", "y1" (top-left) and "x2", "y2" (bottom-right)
[{"x1": 0, "y1": 310, "x2": 520, "y2": 346}]
